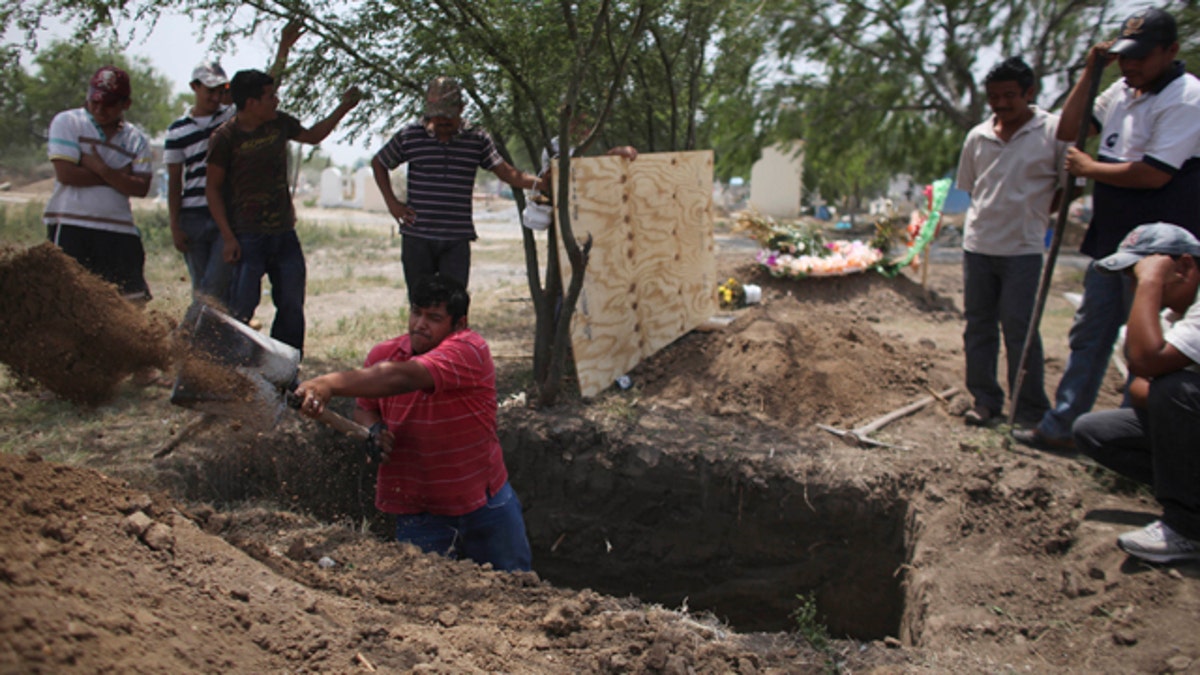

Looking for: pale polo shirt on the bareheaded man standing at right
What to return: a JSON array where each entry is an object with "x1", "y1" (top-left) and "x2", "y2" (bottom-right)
[{"x1": 956, "y1": 106, "x2": 1067, "y2": 256}]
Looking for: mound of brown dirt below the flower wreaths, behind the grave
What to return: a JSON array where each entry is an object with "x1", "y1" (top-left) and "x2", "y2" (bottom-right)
[{"x1": 631, "y1": 274, "x2": 952, "y2": 426}]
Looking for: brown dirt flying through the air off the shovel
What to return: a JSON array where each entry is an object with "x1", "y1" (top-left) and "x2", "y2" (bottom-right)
[{"x1": 0, "y1": 243, "x2": 172, "y2": 405}]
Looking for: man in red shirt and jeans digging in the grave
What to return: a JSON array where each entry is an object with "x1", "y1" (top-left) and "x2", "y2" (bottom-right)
[{"x1": 296, "y1": 275, "x2": 532, "y2": 572}]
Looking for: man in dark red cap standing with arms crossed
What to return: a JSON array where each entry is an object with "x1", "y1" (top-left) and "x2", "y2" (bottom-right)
[{"x1": 42, "y1": 66, "x2": 150, "y2": 301}]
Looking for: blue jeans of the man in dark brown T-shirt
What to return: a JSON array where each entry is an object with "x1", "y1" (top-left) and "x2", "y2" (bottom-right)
[{"x1": 229, "y1": 229, "x2": 307, "y2": 352}]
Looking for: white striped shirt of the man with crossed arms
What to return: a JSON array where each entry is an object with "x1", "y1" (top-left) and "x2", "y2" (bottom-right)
[{"x1": 42, "y1": 108, "x2": 150, "y2": 230}]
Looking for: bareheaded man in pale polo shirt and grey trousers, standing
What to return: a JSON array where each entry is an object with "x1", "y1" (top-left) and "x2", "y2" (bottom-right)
[{"x1": 958, "y1": 56, "x2": 1066, "y2": 426}]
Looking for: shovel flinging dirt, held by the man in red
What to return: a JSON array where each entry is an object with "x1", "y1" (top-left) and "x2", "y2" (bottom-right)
[{"x1": 170, "y1": 303, "x2": 370, "y2": 441}]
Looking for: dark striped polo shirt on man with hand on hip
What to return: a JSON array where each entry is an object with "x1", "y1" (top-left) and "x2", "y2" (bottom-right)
[{"x1": 376, "y1": 123, "x2": 504, "y2": 240}]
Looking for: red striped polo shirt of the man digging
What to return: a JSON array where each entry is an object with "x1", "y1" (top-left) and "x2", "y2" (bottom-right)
[{"x1": 358, "y1": 330, "x2": 509, "y2": 515}]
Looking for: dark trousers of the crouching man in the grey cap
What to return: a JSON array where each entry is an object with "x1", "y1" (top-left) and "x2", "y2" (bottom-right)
[{"x1": 1074, "y1": 370, "x2": 1200, "y2": 540}]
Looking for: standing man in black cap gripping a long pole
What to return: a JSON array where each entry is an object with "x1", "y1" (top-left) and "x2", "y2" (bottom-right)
[{"x1": 1013, "y1": 10, "x2": 1200, "y2": 449}]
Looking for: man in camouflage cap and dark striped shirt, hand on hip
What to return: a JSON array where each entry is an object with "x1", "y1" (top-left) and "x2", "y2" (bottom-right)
[{"x1": 371, "y1": 77, "x2": 540, "y2": 288}]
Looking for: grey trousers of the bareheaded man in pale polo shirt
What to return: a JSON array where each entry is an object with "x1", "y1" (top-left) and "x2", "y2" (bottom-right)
[{"x1": 962, "y1": 251, "x2": 1050, "y2": 422}]
